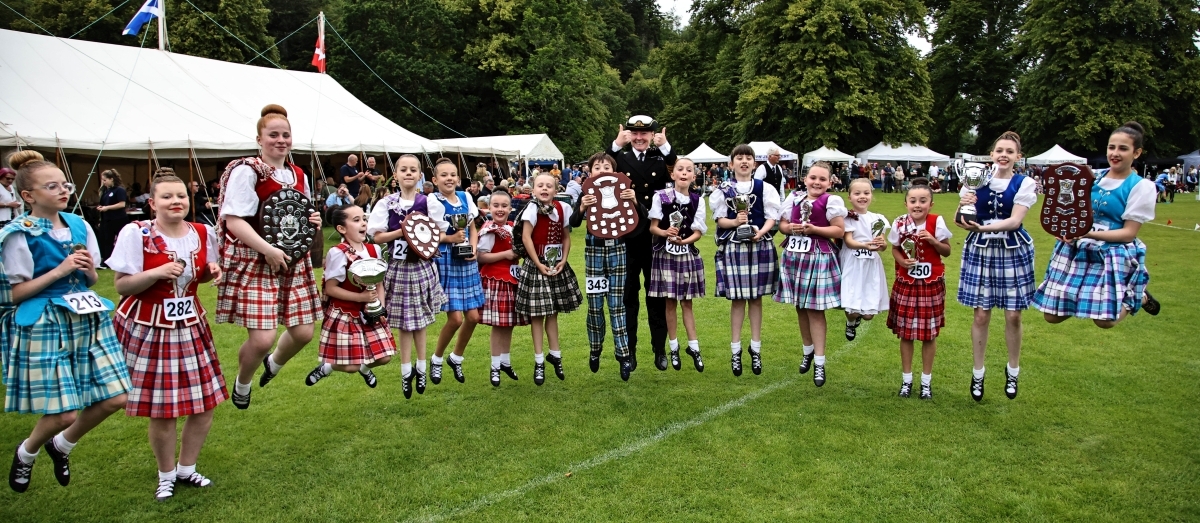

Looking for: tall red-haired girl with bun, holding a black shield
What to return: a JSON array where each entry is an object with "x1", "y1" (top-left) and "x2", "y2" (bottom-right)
[{"x1": 217, "y1": 104, "x2": 322, "y2": 409}]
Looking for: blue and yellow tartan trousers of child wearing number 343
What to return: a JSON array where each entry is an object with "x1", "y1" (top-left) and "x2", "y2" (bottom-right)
[{"x1": 583, "y1": 241, "x2": 629, "y2": 359}]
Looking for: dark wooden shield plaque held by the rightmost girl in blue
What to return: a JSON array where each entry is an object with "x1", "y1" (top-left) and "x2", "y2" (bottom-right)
[{"x1": 1042, "y1": 163, "x2": 1096, "y2": 240}]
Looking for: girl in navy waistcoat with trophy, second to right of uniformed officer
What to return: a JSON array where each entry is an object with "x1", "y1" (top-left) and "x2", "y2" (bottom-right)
[{"x1": 708, "y1": 144, "x2": 780, "y2": 375}]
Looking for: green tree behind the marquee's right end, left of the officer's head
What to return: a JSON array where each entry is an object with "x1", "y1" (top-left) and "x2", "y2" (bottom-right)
[{"x1": 467, "y1": 0, "x2": 625, "y2": 158}]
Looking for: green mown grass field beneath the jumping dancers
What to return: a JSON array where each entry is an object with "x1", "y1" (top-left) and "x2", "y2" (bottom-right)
[{"x1": 0, "y1": 189, "x2": 1200, "y2": 522}]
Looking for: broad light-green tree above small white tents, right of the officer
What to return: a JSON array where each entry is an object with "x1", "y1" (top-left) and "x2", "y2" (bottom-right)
[{"x1": 737, "y1": 0, "x2": 932, "y2": 150}]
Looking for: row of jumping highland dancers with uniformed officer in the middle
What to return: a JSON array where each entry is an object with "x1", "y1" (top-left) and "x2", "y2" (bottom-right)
[{"x1": 0, "y1": 106, "x2": 1159, "y2": 500}]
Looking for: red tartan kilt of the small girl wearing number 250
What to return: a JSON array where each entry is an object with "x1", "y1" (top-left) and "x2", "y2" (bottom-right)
[{"x1": 888, "y1": 278, "x2": 946, "y2": 342}]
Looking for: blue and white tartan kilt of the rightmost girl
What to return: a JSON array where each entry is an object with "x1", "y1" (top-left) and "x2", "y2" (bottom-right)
[{"x1": 1033, "y1": 239, "x2": 1150, "y2": 320}]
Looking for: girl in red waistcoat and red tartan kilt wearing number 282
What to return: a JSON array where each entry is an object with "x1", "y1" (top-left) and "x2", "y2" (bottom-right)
[{"x1": 106, "y1": 175, "x2": 229, "y2": 501}]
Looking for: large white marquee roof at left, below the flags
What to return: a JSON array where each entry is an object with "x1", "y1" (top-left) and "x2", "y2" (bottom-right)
[{"x1": 0, "y1": 30, "x2": 496, "y2": 157}]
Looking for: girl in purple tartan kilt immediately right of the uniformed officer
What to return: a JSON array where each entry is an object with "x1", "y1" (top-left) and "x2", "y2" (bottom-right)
[{"x1": 647, "y1": 154, "x2": 708, "y2": 372}]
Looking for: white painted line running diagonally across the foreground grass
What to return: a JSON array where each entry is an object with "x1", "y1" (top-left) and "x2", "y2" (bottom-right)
[{"x1": 408, "y1": 321, "x2": 871, "y2": 522}]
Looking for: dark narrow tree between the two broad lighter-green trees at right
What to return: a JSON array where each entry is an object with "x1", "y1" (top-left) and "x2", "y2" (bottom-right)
[{"x1": 928, "y1": 0, "x2": 1024, "y2": 154}]
